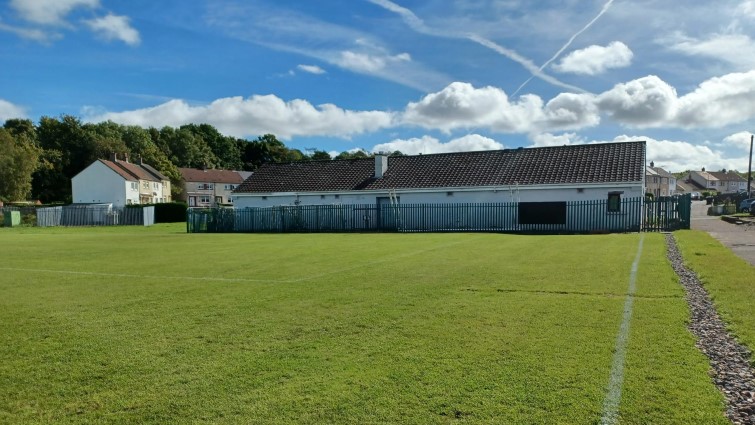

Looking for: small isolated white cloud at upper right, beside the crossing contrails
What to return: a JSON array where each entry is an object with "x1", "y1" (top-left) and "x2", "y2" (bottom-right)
[{"x1": 553, "y1": 41, "x2": 634, "y2": 75}]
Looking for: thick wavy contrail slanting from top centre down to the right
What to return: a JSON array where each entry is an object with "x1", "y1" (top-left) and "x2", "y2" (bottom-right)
[{"x1": 367, "y1": 0, "x2": 588, "y2": 93}]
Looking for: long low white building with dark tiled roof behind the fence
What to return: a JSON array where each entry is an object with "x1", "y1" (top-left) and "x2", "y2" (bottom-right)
[{"x1": 233, "y1": 142, "x2": 645, "y2": 213}]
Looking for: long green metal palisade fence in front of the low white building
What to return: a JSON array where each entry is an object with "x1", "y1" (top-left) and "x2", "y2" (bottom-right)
[{"x1": 186, "y1": 195, "x2": 691, "y2": 233}]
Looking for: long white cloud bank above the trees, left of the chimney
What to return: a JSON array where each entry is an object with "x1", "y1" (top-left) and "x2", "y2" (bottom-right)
[{"x1": 87, "y1": 95, "x2": 393, "y2": 139}]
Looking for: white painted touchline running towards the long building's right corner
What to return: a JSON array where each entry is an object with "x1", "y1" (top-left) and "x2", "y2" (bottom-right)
[{"x1": 600, "y1": 234, "x2": 645, "y2": 425}]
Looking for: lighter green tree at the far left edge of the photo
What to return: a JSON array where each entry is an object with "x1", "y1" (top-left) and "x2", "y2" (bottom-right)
[{"x1": 0, "y1": 128, "x2": 39, "y2": 201}]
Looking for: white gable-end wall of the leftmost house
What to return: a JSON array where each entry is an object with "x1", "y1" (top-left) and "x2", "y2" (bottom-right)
[{"x1": 71, "y1": 161, "x2": 139, "y2": 206}]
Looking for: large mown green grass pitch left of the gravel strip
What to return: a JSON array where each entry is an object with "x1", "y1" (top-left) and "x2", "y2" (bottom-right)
[{"x1": 0, "y1": 225, "x2": 726, "y2": 424}]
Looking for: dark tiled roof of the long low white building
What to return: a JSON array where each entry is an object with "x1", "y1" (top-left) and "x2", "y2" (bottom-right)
[{"x1": 235, "y1": 142, "x2": 645, "y2": 193}]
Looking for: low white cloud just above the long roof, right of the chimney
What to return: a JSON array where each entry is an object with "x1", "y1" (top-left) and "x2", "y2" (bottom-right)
[{"x1": 372, "y1": 134, "x2": 504, "y2": 155}]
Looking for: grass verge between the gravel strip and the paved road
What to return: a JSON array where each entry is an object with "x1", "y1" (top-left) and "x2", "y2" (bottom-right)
[{"x1": 675, "y1": 230, "x2": 755, "y2": 354}]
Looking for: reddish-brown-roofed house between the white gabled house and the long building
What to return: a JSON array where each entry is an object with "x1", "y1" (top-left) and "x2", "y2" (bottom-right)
[{"x1": 179, "y1": 168, "x2": 251, "y2": 207}]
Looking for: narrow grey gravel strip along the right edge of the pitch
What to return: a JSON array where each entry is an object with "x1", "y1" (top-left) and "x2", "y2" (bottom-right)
[{"x1": 666, "y1": 234, "x2": 755, "y2": 425}]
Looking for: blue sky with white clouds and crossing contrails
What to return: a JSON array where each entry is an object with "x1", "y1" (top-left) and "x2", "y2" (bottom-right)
[{"x1": 0, "y1": 0, "x2": 755, "y2": 172}]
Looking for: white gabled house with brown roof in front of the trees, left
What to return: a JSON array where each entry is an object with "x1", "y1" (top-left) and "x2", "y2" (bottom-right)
[{"x1": 71, "y1": 154, "x2": 171, "y2": 206}]
